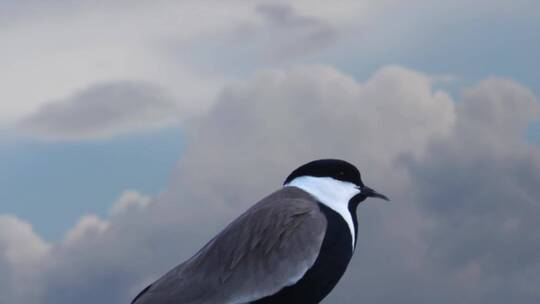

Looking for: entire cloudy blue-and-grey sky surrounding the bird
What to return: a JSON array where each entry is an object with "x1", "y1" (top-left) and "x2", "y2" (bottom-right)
[{"x1": 0, "y1": 0, "x2": 540, "y2": 304}]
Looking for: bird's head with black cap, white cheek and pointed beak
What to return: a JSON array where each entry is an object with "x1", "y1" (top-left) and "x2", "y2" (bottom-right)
[{"x1": 283, "y1": 159, "x2": 389, "y2": 206}]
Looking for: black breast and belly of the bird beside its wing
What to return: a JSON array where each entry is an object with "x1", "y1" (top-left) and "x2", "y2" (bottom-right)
[{"x1": 251, "y1": 203, "x2": 357, "y2": 304}]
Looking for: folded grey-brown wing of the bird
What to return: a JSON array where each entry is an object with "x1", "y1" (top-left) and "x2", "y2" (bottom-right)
[{"x1": 133, "y1": 187, "x2": 327, "y2": 304}]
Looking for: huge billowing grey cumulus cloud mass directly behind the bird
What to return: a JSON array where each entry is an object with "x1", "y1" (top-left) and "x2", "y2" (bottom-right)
[{"x1": 0, "y1": 66, "x2": 540, "y2": 304}]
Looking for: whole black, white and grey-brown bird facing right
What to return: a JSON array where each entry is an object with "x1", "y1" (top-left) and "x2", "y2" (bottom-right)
[{"x1": 132, "y1": 159, "x2": 389, "y2": 304}]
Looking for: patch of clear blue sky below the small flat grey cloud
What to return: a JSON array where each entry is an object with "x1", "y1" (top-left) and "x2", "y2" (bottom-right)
[{"x1": 0, "y1": 127, "x2": 182, "y2": 240}]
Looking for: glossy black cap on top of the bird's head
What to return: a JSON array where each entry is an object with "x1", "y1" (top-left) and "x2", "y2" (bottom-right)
[{"x1": 283, "y1": 159, "x2": 364, "y2": 187}]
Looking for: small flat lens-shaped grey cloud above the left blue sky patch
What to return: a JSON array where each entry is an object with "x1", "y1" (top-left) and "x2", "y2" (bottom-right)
[{"x1": 18, "y1": 81, "x2": 180, "y2": 140}]
